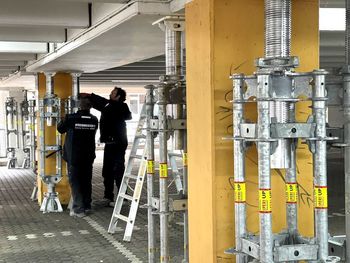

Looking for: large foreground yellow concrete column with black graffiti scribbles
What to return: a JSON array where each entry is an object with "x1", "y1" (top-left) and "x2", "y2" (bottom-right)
[{"x1": 186, "y1": 0, "x2": 319, "y2": 263}]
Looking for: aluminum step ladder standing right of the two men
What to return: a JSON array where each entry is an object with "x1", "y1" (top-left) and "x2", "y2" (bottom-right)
[{"x1": 108, "y1": 104, "x2": 147, "y2": 241}]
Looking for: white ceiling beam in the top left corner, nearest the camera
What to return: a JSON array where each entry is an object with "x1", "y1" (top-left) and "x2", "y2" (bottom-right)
[{"x1": 0, "y1": 0, "x2": 89, "y2": 28}]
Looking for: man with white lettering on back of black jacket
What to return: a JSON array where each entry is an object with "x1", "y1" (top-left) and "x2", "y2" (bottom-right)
[{"x1": 57, "y1": 98, "x2": 98, "y2": 217}]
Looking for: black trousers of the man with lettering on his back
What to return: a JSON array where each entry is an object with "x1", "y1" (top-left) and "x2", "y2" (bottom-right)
[{"x1": 68, "y1": 163, "x2": 92, "y2": 213}]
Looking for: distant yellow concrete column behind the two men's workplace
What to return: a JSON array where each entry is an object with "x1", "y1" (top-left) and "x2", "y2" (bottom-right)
[{"x1": 37, "y1": 73, "x2": 72, "y2": 205}]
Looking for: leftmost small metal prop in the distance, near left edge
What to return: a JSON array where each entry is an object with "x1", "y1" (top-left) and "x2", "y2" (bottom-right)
[{"x1": 5, "y1": 97, "x2": 19, "y2": 169}]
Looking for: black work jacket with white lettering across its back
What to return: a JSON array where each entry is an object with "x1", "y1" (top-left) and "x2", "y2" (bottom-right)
[{"x1": 57, "y1": 110, "x2": 98, "y2": 165}]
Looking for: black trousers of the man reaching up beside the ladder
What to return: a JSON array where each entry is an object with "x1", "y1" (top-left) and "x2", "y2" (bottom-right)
[{"x1": 102, "y1": 144, "x2": 127, "y2": 201}]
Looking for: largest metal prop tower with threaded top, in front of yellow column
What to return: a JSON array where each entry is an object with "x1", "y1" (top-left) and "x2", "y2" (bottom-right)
[{"x1": 227, "y1": 0, "x2": 339, "y2": 263}]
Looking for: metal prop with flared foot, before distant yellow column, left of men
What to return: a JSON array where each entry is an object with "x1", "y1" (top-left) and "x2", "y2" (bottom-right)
[{"x1": 38, "y1": 73, "x2": 63, "y2": 213}]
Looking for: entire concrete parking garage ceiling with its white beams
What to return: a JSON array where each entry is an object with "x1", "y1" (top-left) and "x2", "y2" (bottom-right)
[{"x1": 0, "y1": 0, "x2": 345, "y2": 89}]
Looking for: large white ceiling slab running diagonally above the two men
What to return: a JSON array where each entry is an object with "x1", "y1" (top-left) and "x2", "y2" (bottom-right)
[{"x1": 26, "y1": 2, "x2": 170, "y2": 72}]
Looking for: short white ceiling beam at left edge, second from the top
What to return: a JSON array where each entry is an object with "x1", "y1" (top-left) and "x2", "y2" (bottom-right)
[{"x1": 0, "y1": 25, "x2": 66, "y2": 43}]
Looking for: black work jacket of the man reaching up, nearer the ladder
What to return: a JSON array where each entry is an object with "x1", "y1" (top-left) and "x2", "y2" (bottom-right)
[{"x1": 90, "y1": 93, "x2": 132, "y2": 147}]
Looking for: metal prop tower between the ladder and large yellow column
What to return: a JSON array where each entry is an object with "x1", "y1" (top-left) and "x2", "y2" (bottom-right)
[{"x1": 145, "y1": 16, "x2": 188, "y2": 262}]
